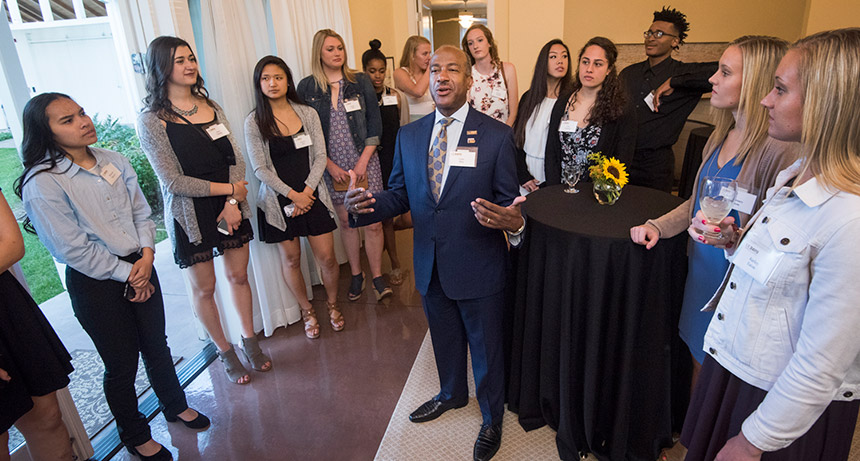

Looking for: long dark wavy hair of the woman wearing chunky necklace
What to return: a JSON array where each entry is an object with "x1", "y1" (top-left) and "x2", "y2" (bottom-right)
[{"x1": 143, "y1": 35, "x2": 212, "y2": 118}]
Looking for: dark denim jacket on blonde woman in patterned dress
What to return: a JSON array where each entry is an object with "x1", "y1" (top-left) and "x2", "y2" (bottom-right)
[{"x1": 296, "y1": 73, "x2": 382, "y2": 154}]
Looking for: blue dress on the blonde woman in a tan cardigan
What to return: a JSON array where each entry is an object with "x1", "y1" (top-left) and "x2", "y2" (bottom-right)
[{"x1": 678, "y1": 145, "x2": 743, "y2": 363}]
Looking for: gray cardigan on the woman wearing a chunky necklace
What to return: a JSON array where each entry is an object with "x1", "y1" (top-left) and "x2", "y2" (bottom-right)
[{"x1": 137, "y1": 101, "x2": 251, "y2": 249}]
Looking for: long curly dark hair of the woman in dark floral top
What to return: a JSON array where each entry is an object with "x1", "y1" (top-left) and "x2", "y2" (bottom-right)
[{"x1": 573, "y1": 37, "x2": 627, "y2": 125}]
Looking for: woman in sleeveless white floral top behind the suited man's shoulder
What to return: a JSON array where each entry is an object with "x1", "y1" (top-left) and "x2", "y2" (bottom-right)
[{"x1": 463, "y1": 24, "x2": 518, "y2": 126}]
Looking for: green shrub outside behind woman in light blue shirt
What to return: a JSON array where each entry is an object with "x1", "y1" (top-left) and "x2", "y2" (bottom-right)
[{"x1": 93, "y1": 115, "x2": 164, "y2": 230}]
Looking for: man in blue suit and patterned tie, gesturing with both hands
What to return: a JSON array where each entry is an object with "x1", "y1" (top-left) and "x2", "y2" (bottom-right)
[{"x1": 344, "y1": 46, "x2": 525, "y2": 461}]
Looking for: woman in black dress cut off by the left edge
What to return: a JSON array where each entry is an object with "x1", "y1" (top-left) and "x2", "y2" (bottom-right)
[{"x1": 0, "y1": 188, "x2": 72, "y2": 461}]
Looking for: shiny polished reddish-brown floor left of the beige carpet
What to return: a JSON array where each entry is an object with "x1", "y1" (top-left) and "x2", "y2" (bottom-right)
[{"x1": 113, "y1": 232, "x2": 427, "y2": 461}]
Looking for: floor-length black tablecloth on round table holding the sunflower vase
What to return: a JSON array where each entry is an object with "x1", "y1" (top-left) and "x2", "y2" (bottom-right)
[{"x1": 507, "y1": 185, "x2": 690, "y2": 461}]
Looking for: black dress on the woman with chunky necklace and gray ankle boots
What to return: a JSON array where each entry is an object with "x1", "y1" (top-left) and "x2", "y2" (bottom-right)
[{"x1": 167, "y1": 118, "x2": 254, "y2": 269}]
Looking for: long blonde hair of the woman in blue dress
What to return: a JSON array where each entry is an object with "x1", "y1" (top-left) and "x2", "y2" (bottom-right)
[{"x1": 705, "y1": 35, "x2": 788, "y2": 165}]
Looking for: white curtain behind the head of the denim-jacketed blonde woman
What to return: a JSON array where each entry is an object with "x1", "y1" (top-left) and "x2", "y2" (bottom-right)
[{"x1": 270, "y1": 0, "x2": 358, "y2": 81}]
